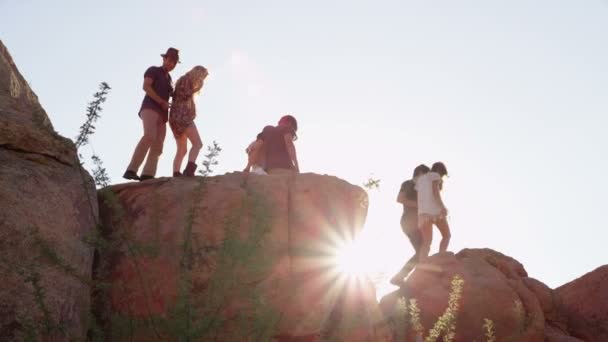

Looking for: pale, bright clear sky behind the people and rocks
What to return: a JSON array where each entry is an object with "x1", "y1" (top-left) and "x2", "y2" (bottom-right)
[{"x1": 0, "y1": 0, "x2": 608, "y2": 300}]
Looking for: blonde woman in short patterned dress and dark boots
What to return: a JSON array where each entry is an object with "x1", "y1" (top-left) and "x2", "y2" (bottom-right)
[{"x1": 169, "y1": 65, "x2": 209, "y2": 177}]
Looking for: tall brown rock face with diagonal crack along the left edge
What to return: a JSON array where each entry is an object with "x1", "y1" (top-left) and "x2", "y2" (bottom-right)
[{"x1": 0, "y1": 42, "x2": 97, "y2": 341}]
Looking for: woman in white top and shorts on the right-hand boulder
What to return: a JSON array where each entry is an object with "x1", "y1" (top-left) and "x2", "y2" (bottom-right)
[{"x1": 415, "y1": 162, "x2": 451, "y2": 264}]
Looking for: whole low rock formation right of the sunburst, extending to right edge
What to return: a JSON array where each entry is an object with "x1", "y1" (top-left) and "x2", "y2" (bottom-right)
[{"x1": 380, "y1": 249, "x2": 608, "y2": 342}]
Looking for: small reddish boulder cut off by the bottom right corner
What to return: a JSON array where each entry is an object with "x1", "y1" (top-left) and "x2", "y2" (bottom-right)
[{"x1": 555, "y1": 265, "x2": 608, "y2": 342}]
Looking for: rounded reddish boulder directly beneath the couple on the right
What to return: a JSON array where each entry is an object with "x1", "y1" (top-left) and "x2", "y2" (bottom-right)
[{"x1": 380, "y1": 249, "x2": 545, "y2": 341}]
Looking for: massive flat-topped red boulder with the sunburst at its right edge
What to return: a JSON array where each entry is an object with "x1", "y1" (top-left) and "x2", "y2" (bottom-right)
[{"x1": 95, "y1": 173, "x2": 380, "y2": 341}]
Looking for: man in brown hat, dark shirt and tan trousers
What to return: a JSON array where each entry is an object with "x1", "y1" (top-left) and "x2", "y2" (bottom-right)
[{"x1": 123, "y1": 48, "x2": 179, "y2": 181}]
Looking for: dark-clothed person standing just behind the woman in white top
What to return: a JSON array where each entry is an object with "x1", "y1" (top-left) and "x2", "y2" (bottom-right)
[{"x1": 390, "y1": 164, "x2": 430, "y2": 286}]
